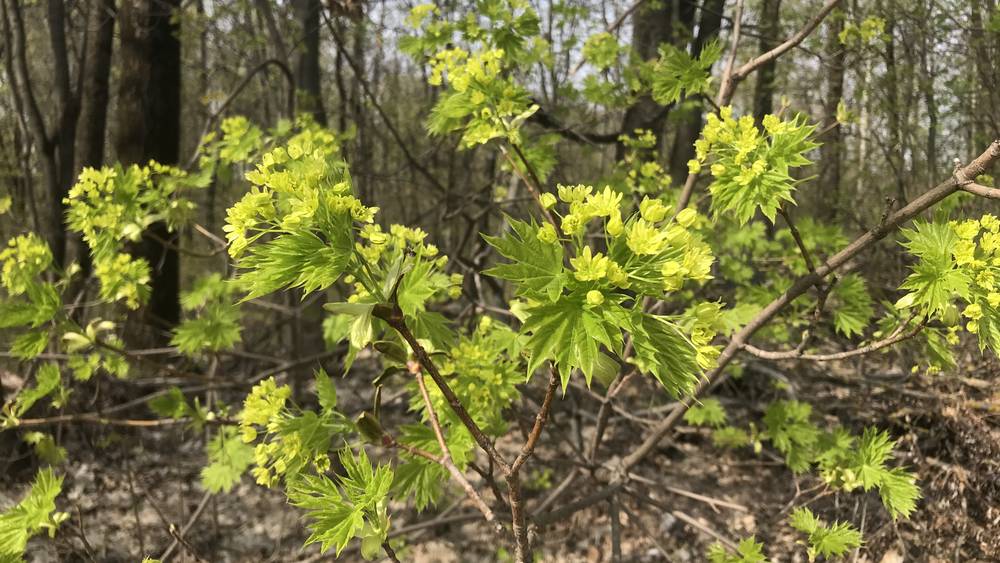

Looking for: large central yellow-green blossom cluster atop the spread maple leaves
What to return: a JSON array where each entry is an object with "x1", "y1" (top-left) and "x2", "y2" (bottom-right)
[{"x1": 538, "y1": 185, "x2": 713, "y2": 305}]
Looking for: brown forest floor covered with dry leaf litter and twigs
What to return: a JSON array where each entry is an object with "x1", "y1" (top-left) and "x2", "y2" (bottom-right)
[{"x1": 0, "y1": 350, "x2": 1000, "y2": 563}]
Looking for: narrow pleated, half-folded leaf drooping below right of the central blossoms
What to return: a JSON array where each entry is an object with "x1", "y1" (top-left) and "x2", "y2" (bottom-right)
[{"x1": 629, "y1": 313, "x2": 702, "y2": 397}]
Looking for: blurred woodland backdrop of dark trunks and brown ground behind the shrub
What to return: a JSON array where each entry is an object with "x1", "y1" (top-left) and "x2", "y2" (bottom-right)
[{"x1": 0, "y1": 0, "x2": 1000, "y2": 561}]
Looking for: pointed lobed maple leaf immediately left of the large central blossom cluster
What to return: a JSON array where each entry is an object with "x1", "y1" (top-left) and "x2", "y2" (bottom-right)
[{"x1": 483, "y1": 218, "x2": 566, "y2": 301}]
